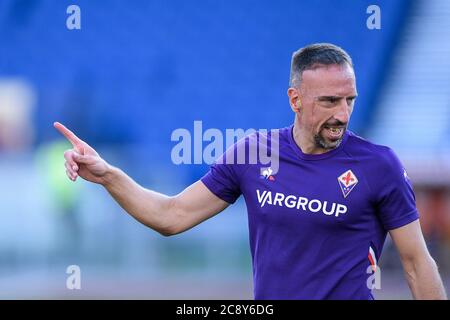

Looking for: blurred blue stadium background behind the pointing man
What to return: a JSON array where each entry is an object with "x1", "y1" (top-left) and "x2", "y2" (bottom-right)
[{"x1": 0, "y1": 0, "x2": 450, "y2": 299}]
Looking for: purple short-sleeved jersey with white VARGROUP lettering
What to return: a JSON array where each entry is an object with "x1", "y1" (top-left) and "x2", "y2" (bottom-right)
[{"x1": 201, "y1": 126, "x2": 419, "y2": 299}]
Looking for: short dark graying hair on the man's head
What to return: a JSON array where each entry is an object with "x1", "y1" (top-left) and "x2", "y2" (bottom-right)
[{"x1": 289, "y1": 43, "x2": 353, "y2": 87}]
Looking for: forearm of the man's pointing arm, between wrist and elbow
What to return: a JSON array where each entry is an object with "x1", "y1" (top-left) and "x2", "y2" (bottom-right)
[{"x1": 102, "y1": 166, "x2": 177, "y2": 235}]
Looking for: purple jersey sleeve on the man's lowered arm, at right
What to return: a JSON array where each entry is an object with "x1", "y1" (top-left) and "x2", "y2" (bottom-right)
[{"x1": 375, "y1": 148, "x2": 419, "y2": 230}]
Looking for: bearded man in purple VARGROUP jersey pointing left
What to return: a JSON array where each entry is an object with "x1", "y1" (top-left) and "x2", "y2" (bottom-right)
[{"x1": 55, "y1": 44, "x2": 446, "y2": 299}]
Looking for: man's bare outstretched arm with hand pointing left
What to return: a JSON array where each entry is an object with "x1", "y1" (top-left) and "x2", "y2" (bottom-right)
[{"x1": 55, "y1": 123, "x2": 228, "y2": 236}]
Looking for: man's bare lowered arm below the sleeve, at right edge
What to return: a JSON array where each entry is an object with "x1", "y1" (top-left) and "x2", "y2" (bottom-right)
[{"x1": 389, "y1": 220, "x2": 447, "y2": 300}]
